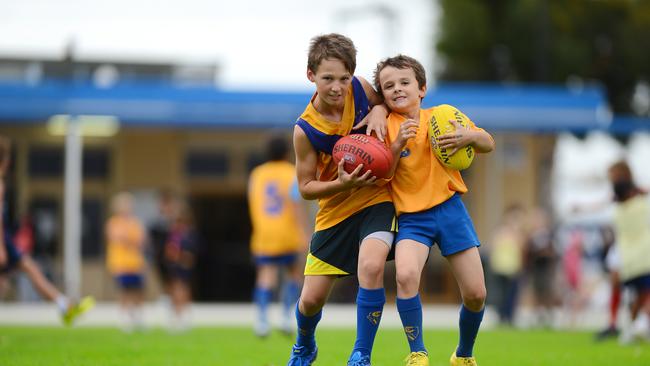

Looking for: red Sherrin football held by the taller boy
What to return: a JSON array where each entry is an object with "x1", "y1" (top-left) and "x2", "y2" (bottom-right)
[{"x1": 332, "y1": 134, "x2": 393, "y2": 178}]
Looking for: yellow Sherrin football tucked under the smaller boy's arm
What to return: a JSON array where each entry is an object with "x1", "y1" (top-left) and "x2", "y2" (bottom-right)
[{"x1": 429, "y1": 104, "x2": 475, "y2": 170}]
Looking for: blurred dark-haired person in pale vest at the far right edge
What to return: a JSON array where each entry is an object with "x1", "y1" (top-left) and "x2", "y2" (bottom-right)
[{"x1": 608, "y1": 161, "x2": 650, "y2": 343}]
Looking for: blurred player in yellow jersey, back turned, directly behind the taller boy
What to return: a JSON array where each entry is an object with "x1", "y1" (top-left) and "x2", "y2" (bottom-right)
[{"x1": 248, "y1": 135, "x2": 309, "y2": 337}]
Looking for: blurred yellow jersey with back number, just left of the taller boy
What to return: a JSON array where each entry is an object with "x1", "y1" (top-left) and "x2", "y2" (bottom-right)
[{"x1": 248, "y1": 161, "x2": 306, "y2": 256}]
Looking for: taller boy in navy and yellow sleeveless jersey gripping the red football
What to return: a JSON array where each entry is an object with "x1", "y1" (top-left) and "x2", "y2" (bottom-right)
[{"x1": 288, "y1": 34, "x2": 395, "y2": 366}]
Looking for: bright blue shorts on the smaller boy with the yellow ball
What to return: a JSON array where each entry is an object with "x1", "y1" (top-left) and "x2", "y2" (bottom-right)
[{"x1": 395, "y1": 194, "x2": 481, "y2": 257}]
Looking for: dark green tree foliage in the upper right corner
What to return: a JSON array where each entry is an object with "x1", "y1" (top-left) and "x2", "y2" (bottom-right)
[{"x1": 436, "y1": 0, "x2": 650, "y2": 113}]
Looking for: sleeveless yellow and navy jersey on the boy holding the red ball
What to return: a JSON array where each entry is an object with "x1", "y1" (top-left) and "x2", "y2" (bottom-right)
[{"x1": 296, "y1": 77, "x2": 390, "y2": 231}]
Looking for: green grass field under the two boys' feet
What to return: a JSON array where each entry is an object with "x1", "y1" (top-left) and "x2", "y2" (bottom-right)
[{"x1": 0, "y1": 327, "x2": 650, "y2": 366}]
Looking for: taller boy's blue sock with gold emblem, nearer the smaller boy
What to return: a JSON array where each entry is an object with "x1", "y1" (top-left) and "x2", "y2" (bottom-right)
[{"x1": 352, "y1": 287, "x2": 386, "y2": 356}]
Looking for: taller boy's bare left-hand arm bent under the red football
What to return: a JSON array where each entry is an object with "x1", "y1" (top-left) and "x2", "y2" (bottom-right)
[{"x1": 293, "y1": 126, "x2": 376, "y2": 200}]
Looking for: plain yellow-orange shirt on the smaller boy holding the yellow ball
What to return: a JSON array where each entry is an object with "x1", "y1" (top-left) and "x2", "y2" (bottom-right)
[{"x1": 386, "y1": 107, "x2": 481, "y2": 215}]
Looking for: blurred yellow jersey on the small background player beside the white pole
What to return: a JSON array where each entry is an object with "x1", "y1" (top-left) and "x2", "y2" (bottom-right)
[{"x1": 106, "y1": 216, "x2": 144, "y2": 275}]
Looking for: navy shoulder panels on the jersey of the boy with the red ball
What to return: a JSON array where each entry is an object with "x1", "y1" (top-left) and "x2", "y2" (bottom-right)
[{"x1": 296, "y1": 76, "x2": 370, "y2": 155}]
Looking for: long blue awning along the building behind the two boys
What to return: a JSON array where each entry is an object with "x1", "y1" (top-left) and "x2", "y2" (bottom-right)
[{"x1": 0, "y1": 80, "x2": 628, "y2": 132}]
